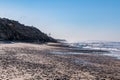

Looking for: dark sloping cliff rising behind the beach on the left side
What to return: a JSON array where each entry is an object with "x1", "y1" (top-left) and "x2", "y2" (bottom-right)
[{"x1": 0, "y1": 18, "x2": 56, "y2": 42}]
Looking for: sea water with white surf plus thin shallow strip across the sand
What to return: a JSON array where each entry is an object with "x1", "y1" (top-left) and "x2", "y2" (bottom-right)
[{"x1": 52, "y1": 41, "x2": 120, "y2": 59}]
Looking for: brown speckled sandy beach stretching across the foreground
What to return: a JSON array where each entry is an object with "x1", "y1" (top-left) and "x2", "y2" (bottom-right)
[{"x1": 0, "y1": 43, "x2": 120, "y2": 80}]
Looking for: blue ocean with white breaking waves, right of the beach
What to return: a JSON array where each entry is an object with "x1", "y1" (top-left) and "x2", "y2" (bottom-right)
[{"x1": 70, "y1": 41, "x2": 120, "y2": 59}]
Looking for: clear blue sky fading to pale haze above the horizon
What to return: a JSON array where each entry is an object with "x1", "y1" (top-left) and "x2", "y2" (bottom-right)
[{"x1": 0, "y1": 0, "x2": 120, "y2": 42}]
